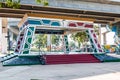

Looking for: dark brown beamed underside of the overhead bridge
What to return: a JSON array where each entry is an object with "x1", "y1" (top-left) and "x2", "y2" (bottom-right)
[{"x1": 0, "y1": 3, "x2": 120, "y2": 24}]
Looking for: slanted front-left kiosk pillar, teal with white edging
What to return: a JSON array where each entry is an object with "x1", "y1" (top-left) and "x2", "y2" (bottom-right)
[{"x1": 21, "y1": 25, "x2": 35, "y2": 54}]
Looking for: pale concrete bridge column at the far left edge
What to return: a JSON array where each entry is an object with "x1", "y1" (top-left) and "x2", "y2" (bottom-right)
[{"x1": 1, "y1": 18, "x2": 8, "y2": 53}]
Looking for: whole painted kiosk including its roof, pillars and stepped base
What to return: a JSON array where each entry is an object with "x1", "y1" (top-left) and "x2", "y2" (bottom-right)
[{"x1": 2, "y1": 14, "x2": 103, "y2": 65}]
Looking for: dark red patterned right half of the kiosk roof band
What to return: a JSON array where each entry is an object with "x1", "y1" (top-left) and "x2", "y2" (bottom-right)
[{"x1": 68, "y1": 22, "x2": 93, "y2": 28}]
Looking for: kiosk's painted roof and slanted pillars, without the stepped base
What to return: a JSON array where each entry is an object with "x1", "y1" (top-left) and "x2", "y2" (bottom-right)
[{"x1": 15, "y1": 15, "x2": 102, "y2": 54}]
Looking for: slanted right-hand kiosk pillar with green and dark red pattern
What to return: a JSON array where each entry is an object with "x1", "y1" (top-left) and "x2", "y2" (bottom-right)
[{"x1": 86, "y1": 29, "x2": 103, "y2": 52}]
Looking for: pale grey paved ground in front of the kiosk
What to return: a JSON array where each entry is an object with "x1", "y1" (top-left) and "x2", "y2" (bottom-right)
[{"x1": 0, "y1": 62, "x2": 120, "y2": 80}]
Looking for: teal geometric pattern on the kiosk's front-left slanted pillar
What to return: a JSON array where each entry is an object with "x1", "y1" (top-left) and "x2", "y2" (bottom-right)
[{"x1": 22, "y1": 27, "x2": 35, "y2": 54}]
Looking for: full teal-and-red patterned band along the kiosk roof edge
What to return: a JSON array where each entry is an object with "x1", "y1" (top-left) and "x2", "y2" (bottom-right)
[{"x1": 20, "y1": 18, "x2": 93, "y2": 30}]
